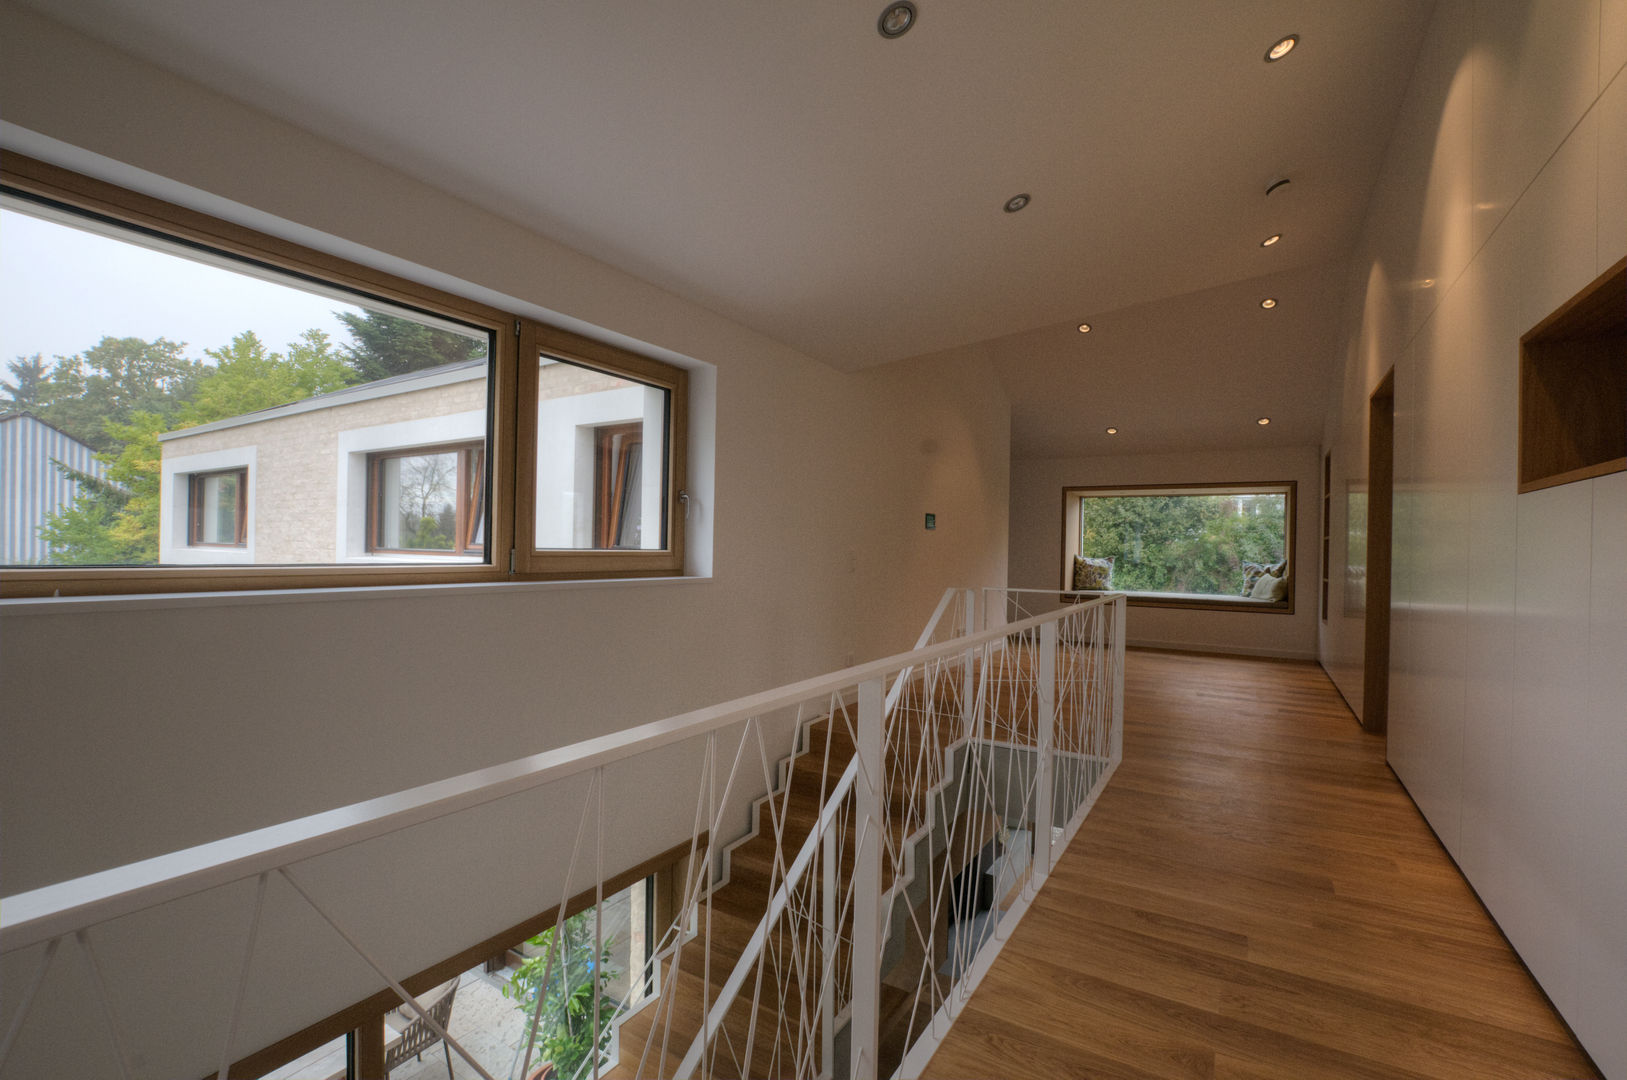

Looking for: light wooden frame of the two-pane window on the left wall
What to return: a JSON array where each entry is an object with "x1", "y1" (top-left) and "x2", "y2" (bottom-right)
[{"x1": 0, "y1": 153, "x2": 688, "y2": 599}]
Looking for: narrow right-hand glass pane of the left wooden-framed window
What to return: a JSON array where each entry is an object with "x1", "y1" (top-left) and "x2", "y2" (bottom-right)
[{"x1": 537, "y1": 356, "x2": 672, "y2": 551}]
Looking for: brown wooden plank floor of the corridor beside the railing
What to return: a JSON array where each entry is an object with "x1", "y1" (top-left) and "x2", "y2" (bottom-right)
[{"x1": 923, "y1": 652, "x2": 1598, "y2": 1080}]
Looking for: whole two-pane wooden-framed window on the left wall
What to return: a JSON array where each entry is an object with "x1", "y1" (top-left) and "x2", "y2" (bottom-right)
[{"x1": 0, "y1": 155, "x2": 685, "y2": 595}]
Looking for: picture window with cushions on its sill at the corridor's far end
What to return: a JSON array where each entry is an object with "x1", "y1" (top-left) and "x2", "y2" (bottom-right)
[{"x1": 1062, "y1": 481, "x2": 1295, "y2": 612}]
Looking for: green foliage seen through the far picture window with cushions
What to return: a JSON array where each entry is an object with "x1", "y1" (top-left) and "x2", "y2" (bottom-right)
[{"x1": 1079, "y1": 494, "x2": 1287, "y2": 595}]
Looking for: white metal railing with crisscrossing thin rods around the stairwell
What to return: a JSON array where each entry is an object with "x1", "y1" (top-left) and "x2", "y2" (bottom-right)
[{"x1": 0, "y1": 590, "x2": 1124, "y2": 1080}]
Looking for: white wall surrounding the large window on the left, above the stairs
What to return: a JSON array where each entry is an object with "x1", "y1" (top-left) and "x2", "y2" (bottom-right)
[{"x1": 0, "y1": 3, "x2": 1010, "y2": 1077}]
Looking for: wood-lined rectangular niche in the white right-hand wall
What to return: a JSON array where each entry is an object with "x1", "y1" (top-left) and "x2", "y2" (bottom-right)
[{"x1": 1520, "y1": 259, "x2": 1627, "y2": 493}]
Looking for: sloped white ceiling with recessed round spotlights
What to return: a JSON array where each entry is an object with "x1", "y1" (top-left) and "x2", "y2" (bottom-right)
[{"x1": 19, "y1": 0, "x2": 1429, "y2": 452}]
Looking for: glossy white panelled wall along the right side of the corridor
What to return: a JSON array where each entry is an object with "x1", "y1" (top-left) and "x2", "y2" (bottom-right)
[{"x1": 1321, "y1": 0, "x2": 1627, "y2": 1078}]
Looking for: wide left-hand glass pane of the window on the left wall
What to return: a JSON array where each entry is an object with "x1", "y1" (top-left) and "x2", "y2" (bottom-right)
[{"x1": 0, "y1": 195, "x2": 493, "y2": 566}]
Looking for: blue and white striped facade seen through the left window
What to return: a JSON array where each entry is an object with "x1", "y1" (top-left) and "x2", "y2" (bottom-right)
[{"x1": 0, "y1": 413, "x2": 107, "y2": 566}]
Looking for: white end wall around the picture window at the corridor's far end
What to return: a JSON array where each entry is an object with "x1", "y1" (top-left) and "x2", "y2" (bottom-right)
[{"x1": 1007, "y1": 447, "x2": 1321, "y2": 660}]
